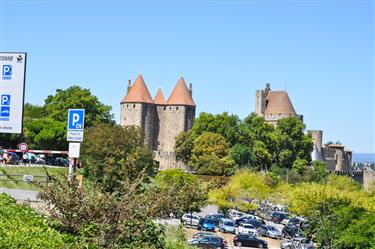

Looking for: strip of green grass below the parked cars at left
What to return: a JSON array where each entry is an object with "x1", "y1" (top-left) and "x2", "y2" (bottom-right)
[{"x1": 0, "y1": 166, "x2": 68, "y2": 190}]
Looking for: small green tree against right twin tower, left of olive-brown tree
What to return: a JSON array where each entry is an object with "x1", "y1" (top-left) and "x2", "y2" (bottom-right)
[{"x1": 174, "y1": 131, "x2": 194, "y2": 164}]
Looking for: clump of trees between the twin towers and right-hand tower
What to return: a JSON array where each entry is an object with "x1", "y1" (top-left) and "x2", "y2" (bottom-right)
[{"x1": 175, "y1": 112, "x2": 313, "y2": 175}]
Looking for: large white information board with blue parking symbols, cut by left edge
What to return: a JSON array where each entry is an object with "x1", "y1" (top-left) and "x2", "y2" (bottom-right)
[{"x1": 0, "y1": 52, "x2": 26, "y2": 133}]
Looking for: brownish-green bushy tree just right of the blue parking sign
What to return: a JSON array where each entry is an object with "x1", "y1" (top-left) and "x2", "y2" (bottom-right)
[{"x1": 81, "y1": 124, "x2": 158, "y2": 194}]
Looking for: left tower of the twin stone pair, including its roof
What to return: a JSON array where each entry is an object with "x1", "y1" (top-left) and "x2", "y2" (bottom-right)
[{"x1": 120, "y1": 75, "x2": 155, "y2": 148}]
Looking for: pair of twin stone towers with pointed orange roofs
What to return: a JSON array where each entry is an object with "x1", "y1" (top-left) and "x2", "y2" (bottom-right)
[{"x1": 120, "y1": 75, "x2": 196, "y2": 170}]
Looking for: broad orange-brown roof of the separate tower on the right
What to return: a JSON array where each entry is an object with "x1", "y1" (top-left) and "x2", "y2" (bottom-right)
[{"x1": 265, "y1": 91, "x2": 296, "y2": 115}]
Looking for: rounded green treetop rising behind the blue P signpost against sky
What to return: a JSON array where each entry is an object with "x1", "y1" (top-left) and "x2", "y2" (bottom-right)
[{"x1": 43, "y1": 86, "x2": 114, "y2": 127}]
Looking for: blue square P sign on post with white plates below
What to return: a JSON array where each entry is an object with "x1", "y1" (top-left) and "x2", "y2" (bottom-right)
[{"x1": 67, "y1": 109, "x2": 85, "y2": 181}]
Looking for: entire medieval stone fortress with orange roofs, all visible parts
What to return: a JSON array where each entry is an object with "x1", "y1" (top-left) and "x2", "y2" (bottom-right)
[{"x1": 120, "y1": 79, "x2": 375, "y2": 188}]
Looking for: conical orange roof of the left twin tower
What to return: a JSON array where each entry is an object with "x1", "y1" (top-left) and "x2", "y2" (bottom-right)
[{"x1": 121, "y1": 75, "x2": 154, "y2": 103}]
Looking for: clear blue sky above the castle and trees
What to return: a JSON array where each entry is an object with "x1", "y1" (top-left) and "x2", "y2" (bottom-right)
[{"x1": 0, "y1": 0, "x2": 375, "y2": 152}]
